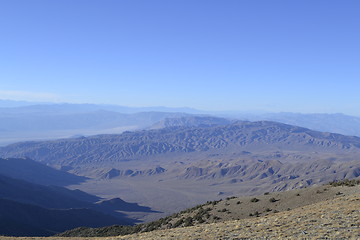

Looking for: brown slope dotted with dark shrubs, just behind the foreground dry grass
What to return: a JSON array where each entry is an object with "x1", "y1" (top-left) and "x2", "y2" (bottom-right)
[{"x1": 55, "y1": 179, "x2": 360, "y2": 238}]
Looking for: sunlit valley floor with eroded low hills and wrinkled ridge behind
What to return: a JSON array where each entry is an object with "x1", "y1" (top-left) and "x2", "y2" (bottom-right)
[{"x1": 0, "y1": 120, "x2": 360, "y2": 222}]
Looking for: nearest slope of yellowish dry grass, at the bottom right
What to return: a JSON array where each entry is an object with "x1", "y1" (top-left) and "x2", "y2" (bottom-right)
[{"x1": 1, "y1": 188, "x2": 360, "y2": 240}]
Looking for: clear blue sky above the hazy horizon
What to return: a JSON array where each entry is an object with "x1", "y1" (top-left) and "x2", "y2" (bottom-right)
[{"x1": 0, "y1": 0, "x2": 360, "y2": 115}]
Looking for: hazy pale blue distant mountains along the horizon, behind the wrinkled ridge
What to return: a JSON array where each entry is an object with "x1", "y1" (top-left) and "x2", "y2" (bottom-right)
[{"x1": 0, "y1": 100, "x2": 360, "y2": 146}]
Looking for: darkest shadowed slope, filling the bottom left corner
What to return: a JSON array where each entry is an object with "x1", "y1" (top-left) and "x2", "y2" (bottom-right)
[{"x1": 0, "y1": 198, "x2": 126, "y2": 236}]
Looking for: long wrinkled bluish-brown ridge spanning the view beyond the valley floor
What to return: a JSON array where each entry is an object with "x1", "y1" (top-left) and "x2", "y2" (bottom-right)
[{"x1": 0, "y1": 122, "x2": 360, "y2": 166}]
